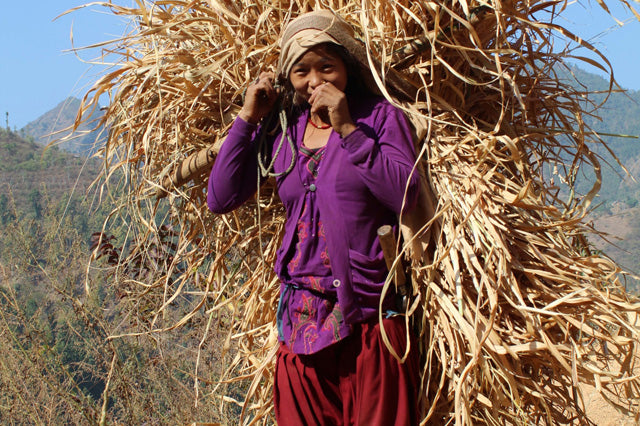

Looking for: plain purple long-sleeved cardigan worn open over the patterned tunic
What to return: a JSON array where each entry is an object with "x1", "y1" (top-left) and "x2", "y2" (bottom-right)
[{"x1": 207, "y1": 97, "x2": 419, "y2": 334}]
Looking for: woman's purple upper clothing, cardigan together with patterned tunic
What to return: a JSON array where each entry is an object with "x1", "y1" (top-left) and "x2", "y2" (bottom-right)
[{"x1": 207, "y1": 98, "x2": 419, "y2": 354}]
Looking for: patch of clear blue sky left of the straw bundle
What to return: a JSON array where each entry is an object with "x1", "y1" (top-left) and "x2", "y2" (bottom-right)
[{"x1": 0, "y1": 0, "x2": 130, "y2": 129}]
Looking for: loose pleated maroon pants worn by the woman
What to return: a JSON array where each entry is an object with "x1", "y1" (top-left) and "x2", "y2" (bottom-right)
[{"x1": 274, "y1": 318, "x2": 419, "y2": 426}]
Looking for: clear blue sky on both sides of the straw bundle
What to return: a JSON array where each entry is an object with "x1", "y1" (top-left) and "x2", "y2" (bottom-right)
[{"x1": 0, "y1": 0, "x2": 640, "y2": 129}]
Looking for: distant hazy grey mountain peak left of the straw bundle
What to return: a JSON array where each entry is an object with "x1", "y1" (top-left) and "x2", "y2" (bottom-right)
[{"x1": 21, "y1": 97, "x2": 104, "y2": 155}]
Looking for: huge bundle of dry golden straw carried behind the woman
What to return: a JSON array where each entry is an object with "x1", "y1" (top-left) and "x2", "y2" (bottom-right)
[{"x1": 78, "y1": 0, "x2": 640, "y2": 424}]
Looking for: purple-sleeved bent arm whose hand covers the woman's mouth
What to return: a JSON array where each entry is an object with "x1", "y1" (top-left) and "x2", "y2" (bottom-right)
[{"x1": 341, "y1": 102, "x2": 420, "y2": 214}]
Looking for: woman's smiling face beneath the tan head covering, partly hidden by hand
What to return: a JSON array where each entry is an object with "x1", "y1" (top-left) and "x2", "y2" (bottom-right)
[{"x1": 289, "y1": 44, "x2": 348, "y2": 101}]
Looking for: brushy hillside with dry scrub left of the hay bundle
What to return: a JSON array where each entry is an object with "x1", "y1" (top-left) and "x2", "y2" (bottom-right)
[{"x1": 0, "y1": 130, "x2": 235, "y2": 424}]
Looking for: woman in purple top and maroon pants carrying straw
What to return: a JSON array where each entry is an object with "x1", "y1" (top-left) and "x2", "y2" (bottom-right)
[{"x1": 208, "y1": 11, "x2": 419, "y2": 425}]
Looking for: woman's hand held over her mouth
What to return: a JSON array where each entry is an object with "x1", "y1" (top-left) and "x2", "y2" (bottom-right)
[{"x1": 309, "y1": 81, "x2": 356, "y2": 138}]
